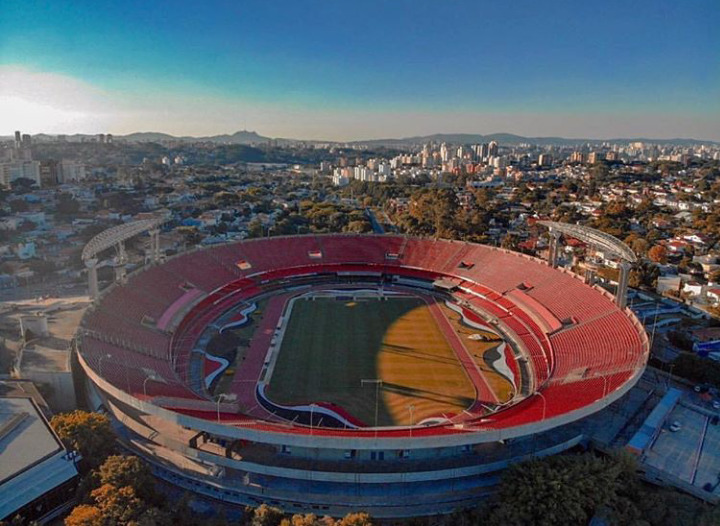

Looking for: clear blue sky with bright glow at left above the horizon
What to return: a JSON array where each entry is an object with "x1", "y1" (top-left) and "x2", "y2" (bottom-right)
[{"x1": 0, "y1": 0, "x2": 720, "y2": 140}]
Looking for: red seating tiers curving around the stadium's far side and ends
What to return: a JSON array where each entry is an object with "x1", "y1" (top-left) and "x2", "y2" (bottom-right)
[{"x1": 82, "y1": 235, "x2": 648, "y2": 438}]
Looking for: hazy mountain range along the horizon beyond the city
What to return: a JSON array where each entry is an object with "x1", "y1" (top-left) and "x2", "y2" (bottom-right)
[{"x1": 0, "y1": 130, "x2": 720, "y2": 148}]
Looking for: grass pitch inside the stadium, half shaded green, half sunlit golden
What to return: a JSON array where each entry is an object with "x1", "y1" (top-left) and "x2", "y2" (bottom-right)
[{"x1": 267, "y1": 298, "x2": 475, "y2": 426}]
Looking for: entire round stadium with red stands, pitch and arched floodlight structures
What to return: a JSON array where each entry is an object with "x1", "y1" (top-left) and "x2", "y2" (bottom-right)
[{"x1": 76, "y1": 232, "x2": 649, "y2": 518}]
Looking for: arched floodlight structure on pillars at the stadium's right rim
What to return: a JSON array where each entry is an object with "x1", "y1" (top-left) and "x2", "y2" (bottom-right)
[{"x1": 538, "y1": 221, "x2": 638, "y2": 309}]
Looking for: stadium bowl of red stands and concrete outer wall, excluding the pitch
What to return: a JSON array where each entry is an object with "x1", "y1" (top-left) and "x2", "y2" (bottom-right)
[{"x1": 76, "y1": 235, "x2": 649, "y2": 517}]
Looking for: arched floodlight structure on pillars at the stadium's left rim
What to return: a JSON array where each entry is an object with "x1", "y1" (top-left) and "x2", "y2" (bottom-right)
[{"x1": 82, "y1": 217, "x2": 166, "y2": 299}]
